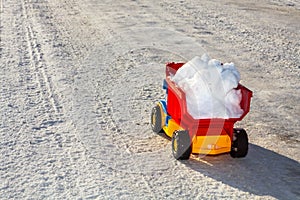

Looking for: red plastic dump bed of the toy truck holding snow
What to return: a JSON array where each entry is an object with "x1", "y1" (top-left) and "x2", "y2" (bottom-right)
[{"x1": 166, "y1": 63, "x2": 252, "y2": 136}]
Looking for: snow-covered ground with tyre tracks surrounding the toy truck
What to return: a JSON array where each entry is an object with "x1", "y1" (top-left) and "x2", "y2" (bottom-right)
[{"x1": 0, "y1": 0, "x2": 300, "y2": 199}]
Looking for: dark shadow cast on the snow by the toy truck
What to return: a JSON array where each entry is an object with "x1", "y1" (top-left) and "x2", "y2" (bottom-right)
[{"x1": 182, "y1": 144, "x2": 300, "y2": 199}]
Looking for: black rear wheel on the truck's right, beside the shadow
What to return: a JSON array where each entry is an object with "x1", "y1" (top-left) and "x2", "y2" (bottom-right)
[{"x1": 230, "y1": 129, "x2": 249, "y2": 158}]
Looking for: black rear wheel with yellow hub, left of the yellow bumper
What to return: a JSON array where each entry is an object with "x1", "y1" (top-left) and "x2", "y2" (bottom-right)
[{"x1": 172, "y1": 130, "x2": 192, "y2": 160}]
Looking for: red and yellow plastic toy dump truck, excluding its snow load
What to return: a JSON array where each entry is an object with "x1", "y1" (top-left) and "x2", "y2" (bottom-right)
[{"x1": 151, "y1": 63, "x2": 252, "y2": 160}]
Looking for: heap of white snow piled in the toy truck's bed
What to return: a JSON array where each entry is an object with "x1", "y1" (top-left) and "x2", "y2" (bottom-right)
[{"x1": 171, "y1": 54, "x2": 243, "y2": 119}]
